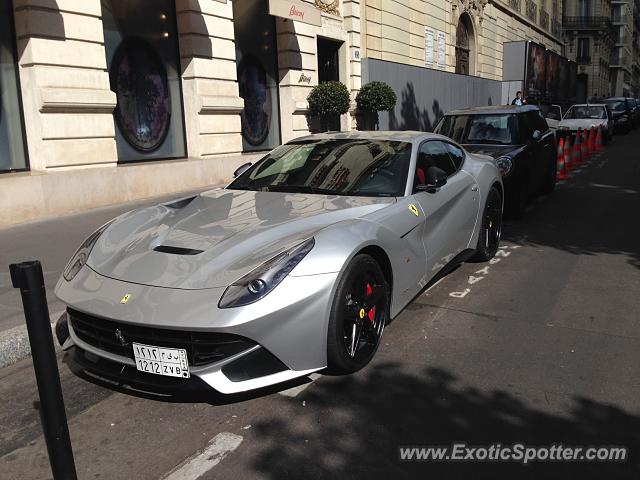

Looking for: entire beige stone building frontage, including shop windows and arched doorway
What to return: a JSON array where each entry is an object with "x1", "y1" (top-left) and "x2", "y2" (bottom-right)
[{"x1": 0, "y1": 0, "x2": 562, "y2": 226}]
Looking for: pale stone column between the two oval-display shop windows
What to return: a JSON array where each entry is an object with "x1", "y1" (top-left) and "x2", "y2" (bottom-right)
[{"x1": 176, "y1": 0, "x2": 244, "y2": 158}]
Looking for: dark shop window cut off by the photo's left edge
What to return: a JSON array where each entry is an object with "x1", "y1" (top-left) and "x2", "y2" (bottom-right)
[{"x1": 0, "y1": 0, "x2": 27, "y2": 172}]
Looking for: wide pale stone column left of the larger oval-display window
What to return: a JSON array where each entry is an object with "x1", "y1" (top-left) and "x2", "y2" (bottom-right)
[{"x1": 14, "y1": 0, "x2": 117, "y2": 170}]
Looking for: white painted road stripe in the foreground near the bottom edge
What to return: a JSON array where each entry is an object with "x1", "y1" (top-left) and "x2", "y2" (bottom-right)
[{"x1": 163, "y1": 432, "x2": 242, "y2": 480}]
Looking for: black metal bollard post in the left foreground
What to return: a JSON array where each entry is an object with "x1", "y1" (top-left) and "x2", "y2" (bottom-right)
[{"x1": 9, "y1": 260, "x2": 77, "y2": 480}]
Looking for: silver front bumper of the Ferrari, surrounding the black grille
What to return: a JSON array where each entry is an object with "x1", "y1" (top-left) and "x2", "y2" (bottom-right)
[{"x1": 56, "y1": 267, "x2": 338, "y2": 394}]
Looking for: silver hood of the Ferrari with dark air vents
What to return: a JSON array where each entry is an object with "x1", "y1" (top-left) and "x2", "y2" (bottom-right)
[{"x1": 87, "y1": 189, "x2": 395, "y2": 289}]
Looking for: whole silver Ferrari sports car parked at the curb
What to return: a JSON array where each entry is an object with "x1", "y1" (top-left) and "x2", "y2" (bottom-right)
[{"x1": 55, "y1": 132, "x2": 503, "y2": 394}]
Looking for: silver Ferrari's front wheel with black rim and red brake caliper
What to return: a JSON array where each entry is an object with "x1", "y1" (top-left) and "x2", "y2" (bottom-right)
[{"x1": 327, "y1": 254, "x2": 390, "y2": 374}]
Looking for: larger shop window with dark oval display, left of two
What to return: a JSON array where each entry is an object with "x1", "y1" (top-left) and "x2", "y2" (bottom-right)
[{"x1": 102, "y1": 0, "x2": 186, "y2": 162}]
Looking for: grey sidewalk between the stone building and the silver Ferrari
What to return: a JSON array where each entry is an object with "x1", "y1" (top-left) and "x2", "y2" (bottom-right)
[{"x1": 0, "y1": 186, "x2": 215, "y2": 368}]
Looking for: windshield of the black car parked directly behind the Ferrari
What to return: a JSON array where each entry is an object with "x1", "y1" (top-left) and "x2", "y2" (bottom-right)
[{"x1": 435, "y1": 114, "x2": 517, "y2": 145}]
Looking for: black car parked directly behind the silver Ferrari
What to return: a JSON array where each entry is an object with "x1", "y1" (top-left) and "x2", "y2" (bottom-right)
[{"x1": 434, "y1": 105, "x2": 556, "y2": 218}]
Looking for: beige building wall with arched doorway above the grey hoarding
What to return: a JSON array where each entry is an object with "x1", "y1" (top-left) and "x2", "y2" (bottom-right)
[{"x1": 362, "y1": 0, "x2": 562, "y2": 80}]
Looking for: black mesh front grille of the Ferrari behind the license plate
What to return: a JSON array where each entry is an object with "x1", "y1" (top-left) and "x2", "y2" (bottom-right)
[{"x1": 67, "y1": 308, "x2": 257, "y2": 366}]
